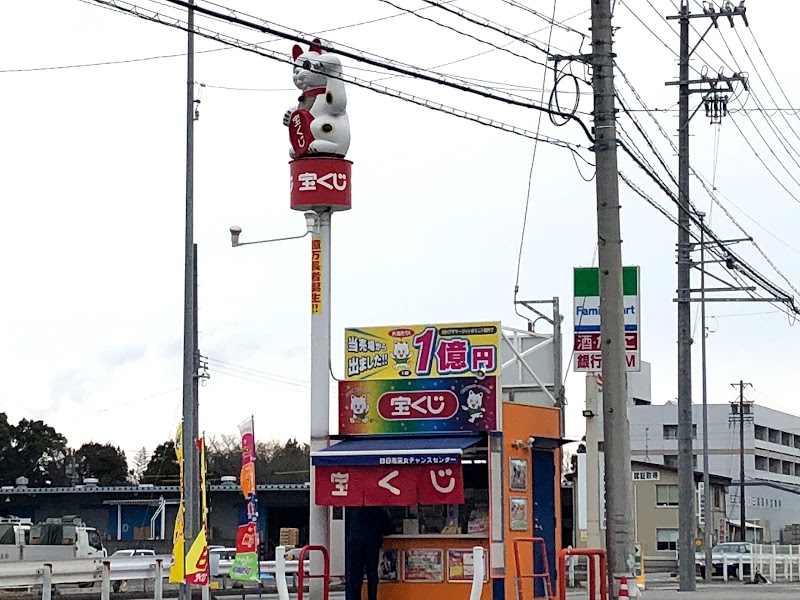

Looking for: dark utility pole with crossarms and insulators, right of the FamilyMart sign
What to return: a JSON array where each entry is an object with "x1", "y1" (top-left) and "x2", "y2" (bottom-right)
[{"x1": 667, "y1": 0, "x2": 747, "y2": 591}]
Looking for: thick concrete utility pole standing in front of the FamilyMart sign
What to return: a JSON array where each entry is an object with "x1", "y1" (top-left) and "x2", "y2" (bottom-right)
[{"x1": 591, "y1": 0, "x2": 635, "y2": 594}]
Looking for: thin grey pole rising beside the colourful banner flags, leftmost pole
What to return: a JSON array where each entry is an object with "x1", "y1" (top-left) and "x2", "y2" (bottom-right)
[{"x1": 181, "y1": 0, "x2": 200, "y2": 598}]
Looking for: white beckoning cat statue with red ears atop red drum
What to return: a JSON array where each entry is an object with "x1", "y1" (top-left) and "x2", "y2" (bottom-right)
[{"x1": 283, "y1": 39, "x2": 350, "y2": 158}]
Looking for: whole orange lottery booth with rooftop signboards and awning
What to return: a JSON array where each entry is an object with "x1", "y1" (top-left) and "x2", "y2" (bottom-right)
[{"x1": 312, "y1": 322, "x2": 563, "y2": 600}]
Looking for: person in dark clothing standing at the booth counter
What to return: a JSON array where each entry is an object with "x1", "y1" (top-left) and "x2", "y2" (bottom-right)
[{"x1": 345, "y1": 506, "x2": 394, "y2": 600}]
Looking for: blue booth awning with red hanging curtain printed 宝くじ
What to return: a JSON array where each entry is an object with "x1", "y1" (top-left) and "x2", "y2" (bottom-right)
[{"x1": 311, "y1": 436, "x2": 482, "y2": 506}]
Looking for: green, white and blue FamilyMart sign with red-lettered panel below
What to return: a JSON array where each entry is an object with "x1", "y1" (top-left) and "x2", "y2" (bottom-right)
[{"x1": 572, "y1": 267, "x2": 641, "y2": 373}]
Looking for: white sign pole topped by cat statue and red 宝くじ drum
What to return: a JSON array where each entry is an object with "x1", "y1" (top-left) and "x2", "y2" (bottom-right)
[{"x1": 283, "y1": 39, "x2": 352, "y2": 600}]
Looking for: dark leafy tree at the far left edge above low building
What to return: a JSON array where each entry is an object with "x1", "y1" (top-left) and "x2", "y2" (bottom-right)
[{"x1": 0, "y1": 413, "x2": 67, "y2": 487}]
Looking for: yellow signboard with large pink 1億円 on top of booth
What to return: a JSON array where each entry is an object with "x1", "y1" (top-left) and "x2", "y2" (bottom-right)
[{"x1": 345, "y1": 321, "x2": 502, "y2": 381}]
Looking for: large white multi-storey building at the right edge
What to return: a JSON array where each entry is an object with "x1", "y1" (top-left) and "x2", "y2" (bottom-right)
[{"x1": 629, "y1": 402, "x2": 800, "y2": 542}]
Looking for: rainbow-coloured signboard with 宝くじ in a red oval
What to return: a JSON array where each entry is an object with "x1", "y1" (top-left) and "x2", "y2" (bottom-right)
[{"x1": 339, "y1": 376, "x2": 498, "y2": 435}]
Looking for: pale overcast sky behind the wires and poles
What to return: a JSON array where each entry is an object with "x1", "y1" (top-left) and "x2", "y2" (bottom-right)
[{"x1": 0, "y1": 0, "x2": 800, "y2": 457}]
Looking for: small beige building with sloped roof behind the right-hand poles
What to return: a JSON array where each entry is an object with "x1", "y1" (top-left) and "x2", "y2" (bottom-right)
[{"x1": 631, "y1": 461, "x2": 731, "y2": 562}]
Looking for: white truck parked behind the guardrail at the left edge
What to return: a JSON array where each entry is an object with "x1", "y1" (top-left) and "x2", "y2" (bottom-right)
[{"x1": 0, "y1": 515, "x2": 107, "y2": 563}]
